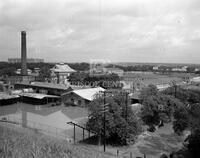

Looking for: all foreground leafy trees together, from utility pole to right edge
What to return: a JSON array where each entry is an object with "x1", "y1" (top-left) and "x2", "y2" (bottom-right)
[{"x1": 87, "y1": 85, "x2": 200, "y2": 150}]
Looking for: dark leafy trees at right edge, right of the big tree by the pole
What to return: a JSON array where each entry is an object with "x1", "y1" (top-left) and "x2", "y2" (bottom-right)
[{"x1": 141, "y1": 85, "x2": 200, "y2": 158}]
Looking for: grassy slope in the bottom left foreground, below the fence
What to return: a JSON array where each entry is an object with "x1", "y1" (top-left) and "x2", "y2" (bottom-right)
[{"x1": 0, "y1": 124, "x2": 117, "y2": 158}]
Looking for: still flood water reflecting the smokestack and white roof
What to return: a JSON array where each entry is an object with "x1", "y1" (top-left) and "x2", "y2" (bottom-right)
[{"x1": 0, "y1": 103, "x2": 88, "y2": 141}]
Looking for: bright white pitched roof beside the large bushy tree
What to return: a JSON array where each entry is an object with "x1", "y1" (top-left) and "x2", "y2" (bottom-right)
[{"x1": 72, "y1": 87, "x2": 105, "y2": 101}]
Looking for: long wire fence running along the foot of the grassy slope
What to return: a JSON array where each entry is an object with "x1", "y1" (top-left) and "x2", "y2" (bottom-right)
[{"x1": 0, "y1": 115, "x2": 147, "y2": 158}]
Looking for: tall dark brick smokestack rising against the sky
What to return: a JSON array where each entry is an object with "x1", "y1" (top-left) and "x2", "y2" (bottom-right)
[{"x1": 21, "y1": 31, "x2": 27, "y2": 76}]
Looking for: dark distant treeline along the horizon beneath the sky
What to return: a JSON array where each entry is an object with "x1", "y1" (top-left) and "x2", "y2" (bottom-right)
[{"x1": 0, "y1": 62, "x2": 200, "y2": 76}]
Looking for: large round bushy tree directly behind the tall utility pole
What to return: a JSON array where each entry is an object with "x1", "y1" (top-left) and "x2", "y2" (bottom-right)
[{"x1": 87, "y1": 93, "x2": 142, "y2": 145}]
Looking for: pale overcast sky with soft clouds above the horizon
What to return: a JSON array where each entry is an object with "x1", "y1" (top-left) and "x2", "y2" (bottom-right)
[{"x1": 0, "y1": 0, "x2": 200, "y2": 63}]
